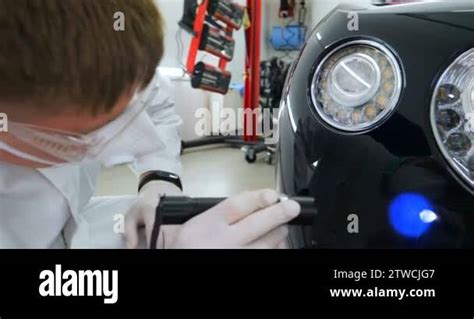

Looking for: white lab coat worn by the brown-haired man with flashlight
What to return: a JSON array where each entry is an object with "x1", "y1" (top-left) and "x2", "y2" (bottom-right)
[{"x1": 0, "y1": 71, "x2": 182, "y2": 248}]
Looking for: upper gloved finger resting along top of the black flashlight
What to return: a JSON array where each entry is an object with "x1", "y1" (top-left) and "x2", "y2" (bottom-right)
[{"x1": 205, "y1": 189, "x2": 279, "y2": 225}]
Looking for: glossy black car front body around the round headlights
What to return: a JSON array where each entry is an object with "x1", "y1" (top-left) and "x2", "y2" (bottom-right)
[{"x1": 277, "y1": 2, "x2": 474, "y2": 248}]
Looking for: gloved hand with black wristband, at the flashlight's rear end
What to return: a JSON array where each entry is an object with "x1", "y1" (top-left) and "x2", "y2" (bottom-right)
[{"x1": 125, "y1": 181, "x2": 182, "y2": 249}]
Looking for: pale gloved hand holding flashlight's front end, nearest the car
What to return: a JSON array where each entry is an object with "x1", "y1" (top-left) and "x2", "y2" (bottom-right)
[{"x1": 166, "y1": 190, "x2": 301, "y2": 249}]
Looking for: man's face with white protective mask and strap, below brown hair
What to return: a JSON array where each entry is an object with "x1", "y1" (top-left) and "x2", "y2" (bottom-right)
[{"x1": 0, "y1": 86, "x2": 163, "y2": 166}]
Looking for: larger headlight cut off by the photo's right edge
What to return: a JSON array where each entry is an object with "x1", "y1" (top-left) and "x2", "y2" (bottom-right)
[{"x1": 431, "y1": 48, "x2": 474, "y2": 187}]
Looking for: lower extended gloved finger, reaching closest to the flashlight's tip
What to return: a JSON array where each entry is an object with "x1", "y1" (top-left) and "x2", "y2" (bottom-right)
[{"x1": 230, "y1": 200, "x2": 301, "y2": 245}]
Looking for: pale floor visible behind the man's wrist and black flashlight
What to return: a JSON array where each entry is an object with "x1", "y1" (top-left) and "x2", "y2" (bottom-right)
[{"x1": 97, "y1": 147, "x2": 275, "y2": 197}]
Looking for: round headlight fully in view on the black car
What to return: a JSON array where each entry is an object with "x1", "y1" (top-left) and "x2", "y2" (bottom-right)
[{"x1": 311, "y1": 40, "x2": 402, "y2": 133}]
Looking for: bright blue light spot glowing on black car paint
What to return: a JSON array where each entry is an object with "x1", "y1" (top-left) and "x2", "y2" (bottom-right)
[{"x1": 390, "y1": 193, "x2": 437, "y2": 237}]
